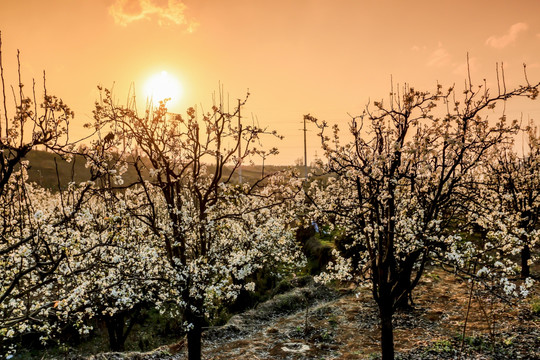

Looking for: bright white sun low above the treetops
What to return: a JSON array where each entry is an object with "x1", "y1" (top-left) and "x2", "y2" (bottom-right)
[{"x1": 144, "y1": 71, "x2": 183, "y2": 107}]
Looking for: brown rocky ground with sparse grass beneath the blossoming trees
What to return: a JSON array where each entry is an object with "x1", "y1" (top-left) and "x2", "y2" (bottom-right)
[{"x1": 82, "y1": 270, "x2": 540, "y2": 360}]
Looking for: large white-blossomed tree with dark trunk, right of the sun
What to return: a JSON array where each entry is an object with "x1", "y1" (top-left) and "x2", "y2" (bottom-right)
[{"x1": 307, "y1": 74, "x2": 540, "y2": 359}]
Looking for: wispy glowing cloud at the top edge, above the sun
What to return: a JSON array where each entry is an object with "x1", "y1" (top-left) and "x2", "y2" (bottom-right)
[{"x1": 109, "y1": 0, "x2": 196, "y2": 28}]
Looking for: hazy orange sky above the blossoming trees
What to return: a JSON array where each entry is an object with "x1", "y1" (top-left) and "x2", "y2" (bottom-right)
[{"x1": 0, "y1": 0, "x2": 540, "y2": 163}]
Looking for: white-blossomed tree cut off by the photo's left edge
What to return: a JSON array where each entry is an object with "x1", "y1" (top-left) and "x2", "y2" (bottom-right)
[{"x1": 0, "y1": 39, "x2": 99, "y2": 352}]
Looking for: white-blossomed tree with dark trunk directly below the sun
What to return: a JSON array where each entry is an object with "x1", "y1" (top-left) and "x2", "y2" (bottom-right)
[{"x1": 91, "y1": 90, "x2": 306, "y2": 359}]
